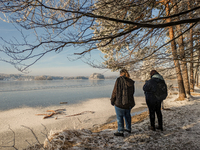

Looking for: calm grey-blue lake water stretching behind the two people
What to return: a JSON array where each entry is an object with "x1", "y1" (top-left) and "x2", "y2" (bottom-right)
[{"x1": 0, "y1": 79, "x2": 144, "y2": 110}]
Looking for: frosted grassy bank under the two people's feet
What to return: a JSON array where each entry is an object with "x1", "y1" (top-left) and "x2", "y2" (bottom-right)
[{"x1": 38, "y1": 89, "x2": 200, "y2": 150}]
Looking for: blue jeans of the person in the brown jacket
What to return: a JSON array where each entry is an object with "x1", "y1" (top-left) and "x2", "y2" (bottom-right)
[{"x1": 115, "y1": 106, "x2": 131, "y2": 132}]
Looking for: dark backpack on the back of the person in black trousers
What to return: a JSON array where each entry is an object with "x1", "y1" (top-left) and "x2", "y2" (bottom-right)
[{"x1": 154, "y1": 81, "x2": 168, "y2": 101}]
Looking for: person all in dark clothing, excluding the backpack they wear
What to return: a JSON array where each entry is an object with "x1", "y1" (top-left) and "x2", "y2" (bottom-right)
[{"x1": 143, "y1": 70, "x2": 164, "y2": 131}]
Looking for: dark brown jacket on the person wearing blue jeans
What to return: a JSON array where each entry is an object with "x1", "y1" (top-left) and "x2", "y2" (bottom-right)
[{"x1": 110, "y1": 76, "x2": 135, "y2": 109}]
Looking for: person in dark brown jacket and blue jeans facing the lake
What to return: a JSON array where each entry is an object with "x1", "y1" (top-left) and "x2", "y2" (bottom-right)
[{"x1": 110, "y1": 69, "x2": 135, "y2": 136}]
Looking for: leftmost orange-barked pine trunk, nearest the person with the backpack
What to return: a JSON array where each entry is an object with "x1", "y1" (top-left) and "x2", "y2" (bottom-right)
[{"x1": 165, "y1": 0, "x2": 186, "y2": 100}]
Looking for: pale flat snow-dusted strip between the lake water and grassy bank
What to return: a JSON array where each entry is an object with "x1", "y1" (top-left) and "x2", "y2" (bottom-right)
[{"x1": 0, "y1": 97, "x2": 146, "y2": 150}]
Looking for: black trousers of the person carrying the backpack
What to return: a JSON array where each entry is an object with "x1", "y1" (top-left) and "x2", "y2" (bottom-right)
[{"x1": 146, "y1": 95, "x2": 163, "y2": 128}]
